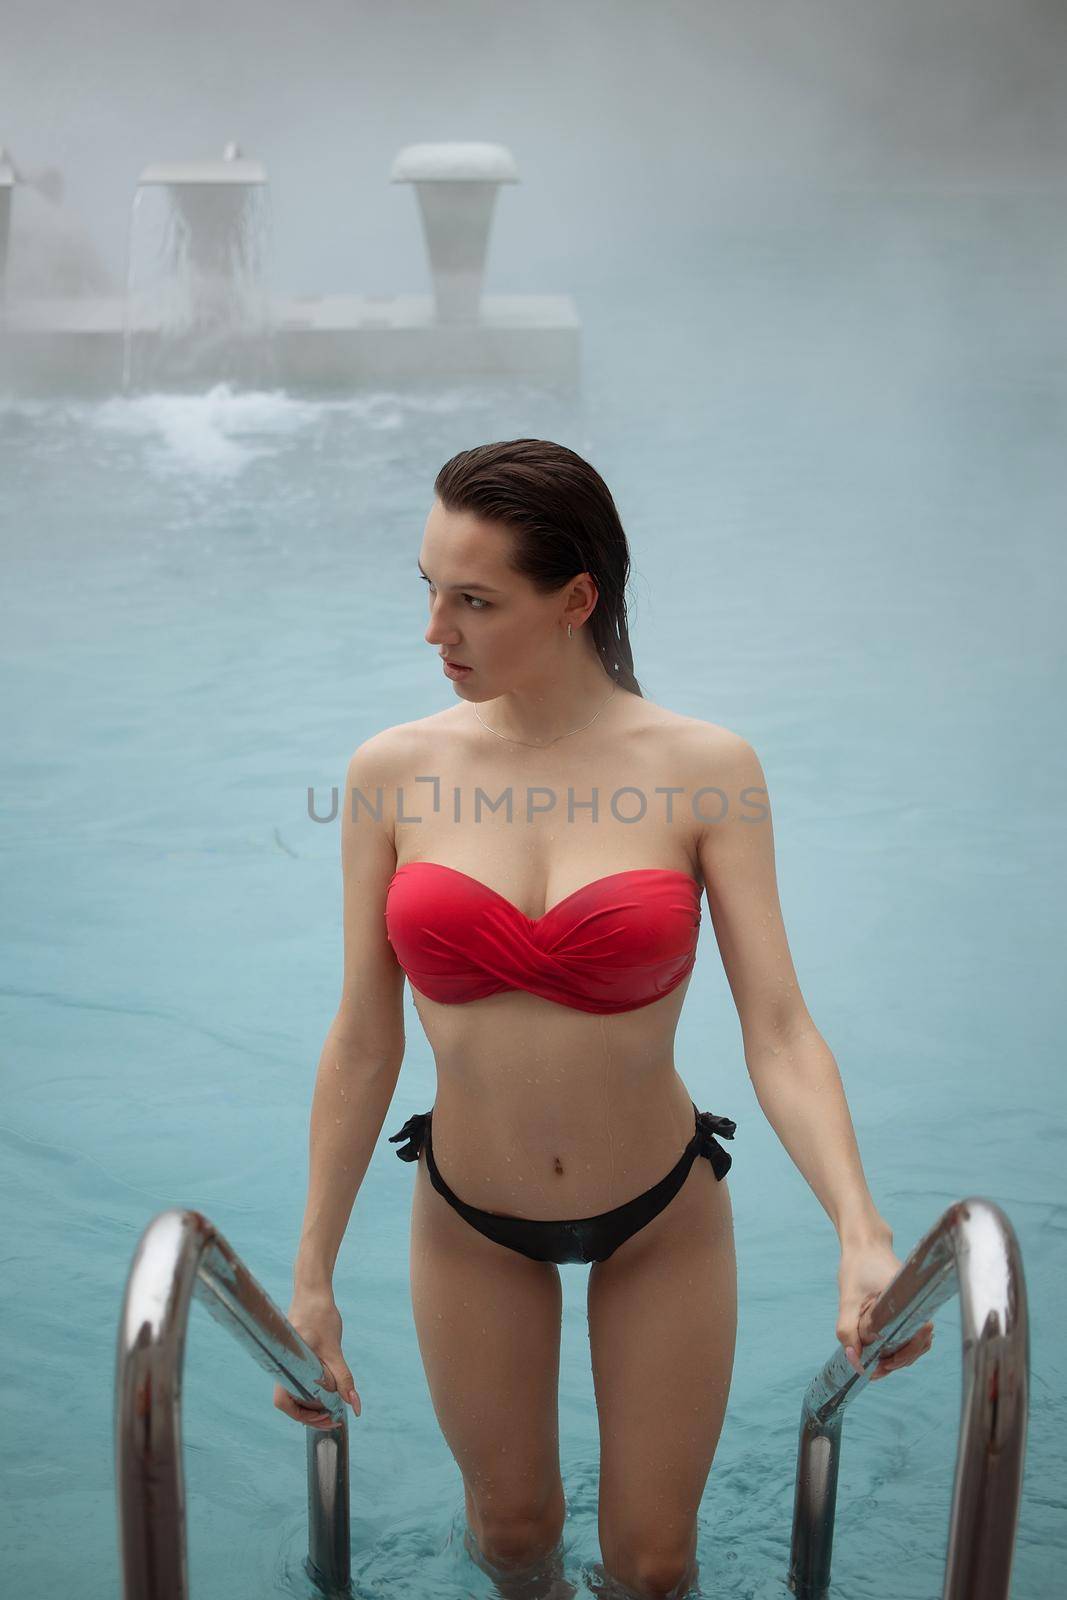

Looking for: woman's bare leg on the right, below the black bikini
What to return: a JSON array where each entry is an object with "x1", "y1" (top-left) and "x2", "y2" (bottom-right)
[{"x1": 589, "y1": 1157, "x2": 737, "y2": 1597}]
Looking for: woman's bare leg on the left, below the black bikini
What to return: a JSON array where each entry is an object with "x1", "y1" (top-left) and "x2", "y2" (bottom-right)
[{"x1": 411, "y1": 1150, "x2": 573, "y2": 1597}]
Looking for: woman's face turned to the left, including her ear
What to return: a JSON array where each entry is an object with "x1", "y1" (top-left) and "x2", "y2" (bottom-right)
[{"x1": 419, "y1": 499, "x2": 593, "y2": 701}]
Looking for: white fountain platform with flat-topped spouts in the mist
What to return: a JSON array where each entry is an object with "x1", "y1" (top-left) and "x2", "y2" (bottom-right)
[{"x1": 0, "y1": 142, "x2": 581, "y2": 394}]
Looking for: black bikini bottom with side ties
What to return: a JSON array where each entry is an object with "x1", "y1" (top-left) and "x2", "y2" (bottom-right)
[{"x1": 389, "y1": 1106, "x2": 737, "y2": 1264}]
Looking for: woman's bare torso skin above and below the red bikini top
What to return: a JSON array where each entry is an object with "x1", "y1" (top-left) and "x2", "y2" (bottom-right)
[{"x1": 383, "y1": 693, "x2": 726, "y2": 1219}]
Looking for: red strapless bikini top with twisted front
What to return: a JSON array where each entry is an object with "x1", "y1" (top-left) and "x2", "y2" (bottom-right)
[{"x1": 386, "y1": 861, "x2": 701, "y2": 1013}]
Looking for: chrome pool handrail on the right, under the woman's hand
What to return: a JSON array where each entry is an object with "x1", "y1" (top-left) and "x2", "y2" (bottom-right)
[{"x1": 789, "y1": 1197, "x2": 1030, "y2": 1600}]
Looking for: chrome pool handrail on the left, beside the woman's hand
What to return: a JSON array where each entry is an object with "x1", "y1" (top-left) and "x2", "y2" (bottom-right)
[{"x1": 115, "y1": 1208, "x2": 352, "y2": 1600}]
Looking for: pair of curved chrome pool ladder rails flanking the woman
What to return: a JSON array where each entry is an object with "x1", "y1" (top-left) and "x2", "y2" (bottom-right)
[{"x1": 115, "y1": 1198, "x2": 1030, "y2": 1600}]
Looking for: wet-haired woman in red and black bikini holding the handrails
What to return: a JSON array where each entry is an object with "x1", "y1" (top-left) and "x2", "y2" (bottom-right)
[{"x1": 275, "y1": 438, "x2": 933, "y2": 1595}]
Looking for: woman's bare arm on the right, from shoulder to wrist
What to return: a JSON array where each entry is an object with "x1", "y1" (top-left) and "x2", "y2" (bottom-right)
[{"x1": 696, "y1": 725, "x2": 893, "y2": 1246}]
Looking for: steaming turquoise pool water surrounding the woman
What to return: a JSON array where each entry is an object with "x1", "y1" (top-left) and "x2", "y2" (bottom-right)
[{"x1": 0, "y1": 200, "x2": 1067, "y2": 1600}]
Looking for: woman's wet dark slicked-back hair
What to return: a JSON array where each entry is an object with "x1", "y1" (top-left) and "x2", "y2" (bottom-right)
[{"x1": 434, "y1": 438, "x2": 643, "y2": 696}]
